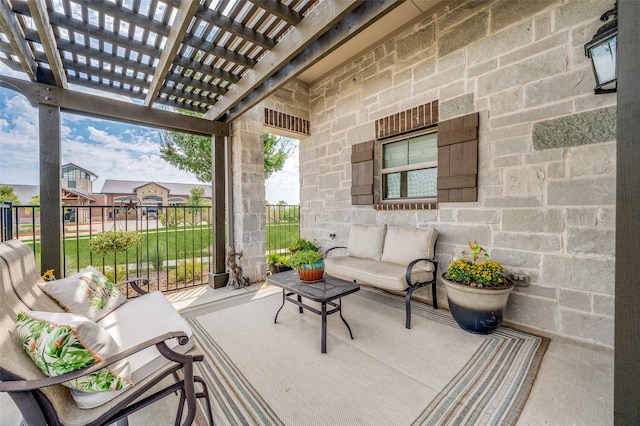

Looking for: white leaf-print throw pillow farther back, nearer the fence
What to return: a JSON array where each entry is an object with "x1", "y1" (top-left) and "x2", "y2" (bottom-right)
[{"x1": 38, "y1": 266, "x2": 127, "y2": 321}]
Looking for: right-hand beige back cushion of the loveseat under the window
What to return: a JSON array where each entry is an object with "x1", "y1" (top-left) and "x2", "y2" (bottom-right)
[{"x1": 380, "y1": 226, "x2": 438, "y2": 267}]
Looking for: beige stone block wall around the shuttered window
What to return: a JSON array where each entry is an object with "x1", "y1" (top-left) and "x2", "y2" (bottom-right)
[{"x1": 300, "y1": 0, "x2": 616, "y2": 346}]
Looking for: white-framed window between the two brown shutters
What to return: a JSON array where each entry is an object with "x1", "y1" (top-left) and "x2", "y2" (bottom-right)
[{"x1": 381, "y1": 131, "x2": 438, "y2": 200}]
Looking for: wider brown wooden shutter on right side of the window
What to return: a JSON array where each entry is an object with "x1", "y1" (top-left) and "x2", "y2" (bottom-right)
[{"x1": 438, "y1": 112, "x2": 479, "y2": 202}]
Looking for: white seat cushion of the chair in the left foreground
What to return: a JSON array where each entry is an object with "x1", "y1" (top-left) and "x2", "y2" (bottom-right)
[{"x1": 71, "y1": 291, "x2": 194, "y2": 408}]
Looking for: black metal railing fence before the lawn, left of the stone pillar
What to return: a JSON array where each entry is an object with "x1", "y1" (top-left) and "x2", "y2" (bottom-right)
[{"x1": 10, "y1": 205, "x2": 213, "y2": 291}]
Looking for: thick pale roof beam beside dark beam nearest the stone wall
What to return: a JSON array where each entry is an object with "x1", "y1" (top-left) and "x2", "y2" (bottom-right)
[{"x1": 205, "y1": 0, "x2": 363, "y2": 120}]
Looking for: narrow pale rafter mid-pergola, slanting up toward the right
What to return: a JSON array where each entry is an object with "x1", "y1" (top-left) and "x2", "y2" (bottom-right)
[{"x1": 144, "y1": 1, "x2": 200, "y2": 106}]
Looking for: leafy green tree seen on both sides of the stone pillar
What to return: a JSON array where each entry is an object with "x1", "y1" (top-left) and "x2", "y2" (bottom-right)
[{"x1": 160, "y1": 120, "x2": 295, "y2": 182}]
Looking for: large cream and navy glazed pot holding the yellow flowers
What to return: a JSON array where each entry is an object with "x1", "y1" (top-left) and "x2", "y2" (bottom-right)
[{"x1": 442, "y1": 274, "x2": 513, "y2": 334}]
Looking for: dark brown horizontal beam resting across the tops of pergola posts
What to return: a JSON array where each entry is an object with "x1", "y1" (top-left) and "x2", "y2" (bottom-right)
[{"x1": 0, "y1": 76, "x2": 229, "y2": 136}]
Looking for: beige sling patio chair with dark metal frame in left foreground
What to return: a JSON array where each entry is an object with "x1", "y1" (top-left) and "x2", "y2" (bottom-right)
[{"x1": 0, "y1": 240, "x2": 213, "y2": 425}]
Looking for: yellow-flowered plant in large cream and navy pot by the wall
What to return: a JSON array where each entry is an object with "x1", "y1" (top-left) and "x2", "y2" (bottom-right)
[{"x1": 442, "y1": 241, "x2": 513, "y2": 334}]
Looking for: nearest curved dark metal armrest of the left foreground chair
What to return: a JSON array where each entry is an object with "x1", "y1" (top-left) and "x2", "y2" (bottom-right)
[{"x1": 0, "y1": 331, "x2": 194, "y2": 392}]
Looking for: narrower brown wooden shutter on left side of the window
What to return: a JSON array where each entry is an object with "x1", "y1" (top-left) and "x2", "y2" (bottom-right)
[{"x1": 351, "y1": 141, "x2": 375, "y2": 205}]
